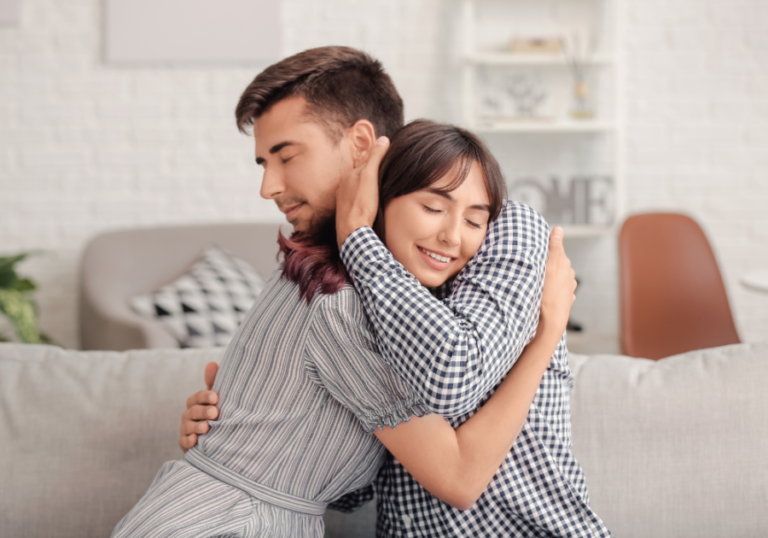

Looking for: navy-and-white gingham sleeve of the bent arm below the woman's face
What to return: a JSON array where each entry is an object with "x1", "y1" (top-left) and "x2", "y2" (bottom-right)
[{"x1": 341, "y1": 201, "x2": 549, "y2": 417}]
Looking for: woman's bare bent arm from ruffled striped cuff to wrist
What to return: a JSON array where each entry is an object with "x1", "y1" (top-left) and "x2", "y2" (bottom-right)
[{"x1": 376, "y1": 320, "x2": 562, "y2": 510}]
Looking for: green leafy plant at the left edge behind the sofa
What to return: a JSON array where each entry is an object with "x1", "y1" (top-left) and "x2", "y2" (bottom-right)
[{"x1": 0, "y1": 252, "x2": 54, "y2": 344}]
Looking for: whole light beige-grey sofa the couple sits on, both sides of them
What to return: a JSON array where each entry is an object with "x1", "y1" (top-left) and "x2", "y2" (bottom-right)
[{"x1": 0, "y1": 344, "x2": 768, "y2": 538}]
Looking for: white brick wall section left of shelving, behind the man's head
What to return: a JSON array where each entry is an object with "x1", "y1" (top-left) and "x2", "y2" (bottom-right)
[{"x1": 0, "y1": 0, "x2": 448, "y2": 346}]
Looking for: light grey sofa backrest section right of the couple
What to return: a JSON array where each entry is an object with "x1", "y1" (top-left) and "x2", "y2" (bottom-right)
[{"x1": 571, "y1": 343, "x2": 768, "y2": 538}]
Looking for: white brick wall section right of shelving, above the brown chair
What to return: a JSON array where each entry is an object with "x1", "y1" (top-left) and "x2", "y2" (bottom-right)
[{"x1": 623, "y1": 0, "x2": 768, "y2": 341}]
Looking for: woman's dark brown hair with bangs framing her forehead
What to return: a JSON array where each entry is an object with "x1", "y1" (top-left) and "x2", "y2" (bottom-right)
[{"x1": 374, "y1": 120, "x2": 507, "y2": 241}]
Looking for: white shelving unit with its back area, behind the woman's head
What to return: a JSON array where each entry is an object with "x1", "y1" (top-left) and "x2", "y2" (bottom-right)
[{"x1": 462, "y1": 0, "x2": 625, "y2": 241}]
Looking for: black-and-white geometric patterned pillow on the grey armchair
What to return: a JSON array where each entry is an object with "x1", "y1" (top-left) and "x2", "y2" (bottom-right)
[{"x1": 131, "y1": 245, "x2": 264, "y2": 347}]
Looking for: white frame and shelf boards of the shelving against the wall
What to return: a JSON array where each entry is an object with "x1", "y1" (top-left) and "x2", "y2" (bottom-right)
[{"x1": 462, "y1": 0, "x2": 624, "y2": 237}]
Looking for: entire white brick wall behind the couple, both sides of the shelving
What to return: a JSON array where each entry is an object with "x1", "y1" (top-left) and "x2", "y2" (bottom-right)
[{"x1": 0, "y1": 0, "x2": 768, "y2": 347}]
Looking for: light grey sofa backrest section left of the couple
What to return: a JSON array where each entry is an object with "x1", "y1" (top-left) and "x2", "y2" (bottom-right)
[{"x1": 0, "y1": 344, "x2": 224, "y2": 538}]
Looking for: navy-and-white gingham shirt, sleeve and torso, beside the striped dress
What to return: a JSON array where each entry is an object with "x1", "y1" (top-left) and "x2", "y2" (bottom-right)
[{"x1": 338, "y1": 202, "x2": 610, "y2": 537}]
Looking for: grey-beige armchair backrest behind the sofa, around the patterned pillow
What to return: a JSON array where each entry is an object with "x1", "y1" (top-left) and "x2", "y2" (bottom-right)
[{"x1": 80, "y1": 223, "x2": 287, "y2": 351}]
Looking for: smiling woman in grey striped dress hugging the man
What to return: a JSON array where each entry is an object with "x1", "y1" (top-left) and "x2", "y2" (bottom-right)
[{"x1": 113, "y1": 122, "x2": 575, "y2": 536}]
